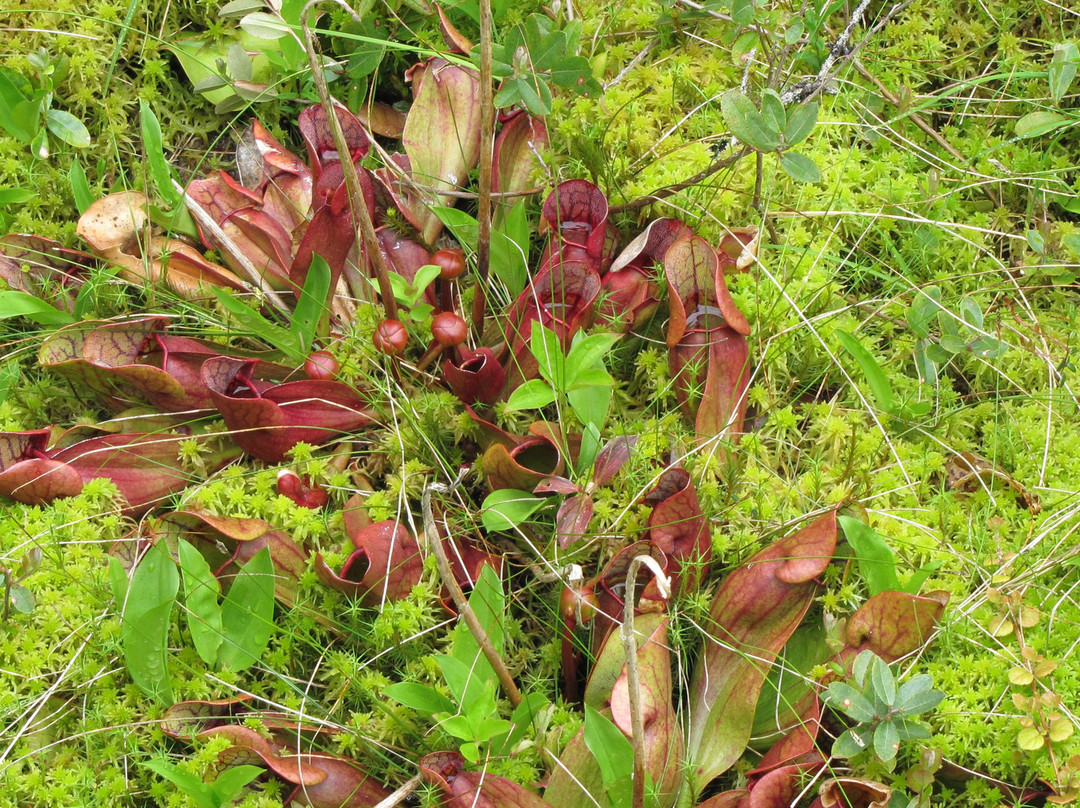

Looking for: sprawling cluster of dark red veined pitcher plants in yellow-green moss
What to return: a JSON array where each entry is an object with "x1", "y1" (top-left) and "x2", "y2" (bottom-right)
[{"x1": 0, "y1": 42, "x2": 944, "y2": 808}]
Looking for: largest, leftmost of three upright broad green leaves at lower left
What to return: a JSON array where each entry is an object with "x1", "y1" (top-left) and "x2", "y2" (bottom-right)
[{"x1": 121, "y1": 542, "x2": 180, "y2": 704}]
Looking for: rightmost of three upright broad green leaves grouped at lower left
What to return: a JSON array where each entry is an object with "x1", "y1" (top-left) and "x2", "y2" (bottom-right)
[{"x1": 218, "y1": 547, "x2": 274, "y2": 673}]
